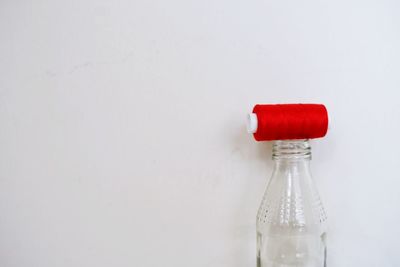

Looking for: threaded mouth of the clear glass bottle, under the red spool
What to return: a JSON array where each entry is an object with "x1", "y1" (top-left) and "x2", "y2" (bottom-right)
[{"x1": 272, "y1": 139, "x2": 311, "y2": 159}]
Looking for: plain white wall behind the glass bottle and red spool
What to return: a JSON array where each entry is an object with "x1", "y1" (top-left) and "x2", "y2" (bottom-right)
[{"x1": 0, "y1": 0, "x2": 400, "y2": 267}]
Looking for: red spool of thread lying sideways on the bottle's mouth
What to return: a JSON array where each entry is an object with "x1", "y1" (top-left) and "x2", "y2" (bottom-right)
[{"x1": 247, "y1": 104, "x2": 328, "y2": 141}]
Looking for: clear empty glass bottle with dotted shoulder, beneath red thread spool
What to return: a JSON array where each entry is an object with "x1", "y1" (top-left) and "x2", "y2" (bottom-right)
[{"x1": 257, "y1": 140, "x2": 327, "y2": 267}]
